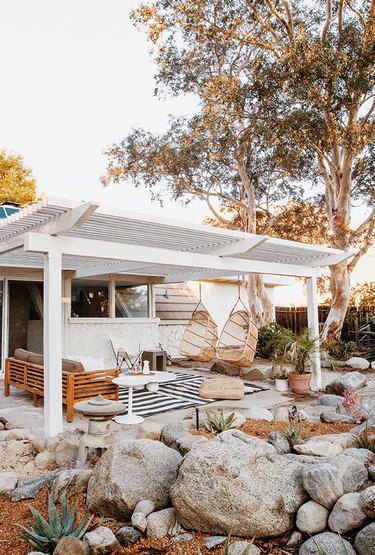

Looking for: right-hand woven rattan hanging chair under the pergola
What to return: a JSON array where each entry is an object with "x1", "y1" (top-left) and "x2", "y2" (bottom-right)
[{"x1": 216, "y1": 297, "x2": 258, "y2": 366}]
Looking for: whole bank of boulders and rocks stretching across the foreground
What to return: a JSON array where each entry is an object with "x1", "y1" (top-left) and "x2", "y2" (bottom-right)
[{"x1": 0, "y1": 368, "x2": 375, "y2": 555}]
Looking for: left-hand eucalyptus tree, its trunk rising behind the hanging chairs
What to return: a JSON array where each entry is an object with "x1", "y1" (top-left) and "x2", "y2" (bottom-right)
[{"x1": 103, "y1": 2, "x2": 310, "y2": 326}]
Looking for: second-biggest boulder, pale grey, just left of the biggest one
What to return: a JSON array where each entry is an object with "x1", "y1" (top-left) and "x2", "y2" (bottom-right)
[{"x1": 87, "y1": 439, "x2": 182, "y2": 520}]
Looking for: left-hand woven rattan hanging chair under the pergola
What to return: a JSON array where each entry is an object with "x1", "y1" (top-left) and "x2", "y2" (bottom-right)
[{"x1": 178, "y1": 301, "x2": 218, "y2": 362}]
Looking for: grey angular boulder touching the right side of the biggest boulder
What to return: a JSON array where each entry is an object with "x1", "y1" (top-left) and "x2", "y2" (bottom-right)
[{"x1": 302, "y1": 464, "x2": 349, "y2": 509}]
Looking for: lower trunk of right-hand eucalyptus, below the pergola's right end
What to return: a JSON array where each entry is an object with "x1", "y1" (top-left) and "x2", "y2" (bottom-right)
[{"x1": 321, "y1": 261, "x2": 350, "y2": 341}]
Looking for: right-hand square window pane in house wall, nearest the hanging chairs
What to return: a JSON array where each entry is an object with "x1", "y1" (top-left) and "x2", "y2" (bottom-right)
[{"x1": 115, "y1": 281, "x2": 148, "y2": 318}]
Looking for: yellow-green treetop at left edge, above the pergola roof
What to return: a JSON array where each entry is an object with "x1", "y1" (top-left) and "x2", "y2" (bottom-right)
[{"x1": 0, "y1": 150, "x2": 36, "y2": 206}]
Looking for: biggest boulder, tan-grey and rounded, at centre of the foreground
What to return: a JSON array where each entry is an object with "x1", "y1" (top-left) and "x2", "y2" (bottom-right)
[{"x1": 171, "y1": 430, "x2": 307, "y2": 537}]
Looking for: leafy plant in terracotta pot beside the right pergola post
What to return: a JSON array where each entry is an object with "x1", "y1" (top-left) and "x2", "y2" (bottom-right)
[{"x1": 278, "y1": 328, "x2": 316, "y2": 395}]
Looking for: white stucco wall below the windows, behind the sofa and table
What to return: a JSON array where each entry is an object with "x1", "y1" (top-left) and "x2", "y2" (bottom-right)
[{"x1": 64, "y1": 318, "x2": 159, "y2": 368}]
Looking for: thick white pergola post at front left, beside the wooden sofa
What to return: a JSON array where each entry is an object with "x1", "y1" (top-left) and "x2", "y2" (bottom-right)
[{"x1": 44, "y1": 250, "x2": 63, "y2": 437}]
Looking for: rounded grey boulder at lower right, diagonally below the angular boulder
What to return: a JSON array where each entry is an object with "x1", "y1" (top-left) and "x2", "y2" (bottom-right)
[{"x1": 328, "y1": 493, "x2": 369, "y2": 534}]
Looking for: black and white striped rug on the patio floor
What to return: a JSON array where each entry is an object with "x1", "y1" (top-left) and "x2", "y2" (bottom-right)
[{"x1": 119, "y1": 374, "x2": 263, "y2": 416}]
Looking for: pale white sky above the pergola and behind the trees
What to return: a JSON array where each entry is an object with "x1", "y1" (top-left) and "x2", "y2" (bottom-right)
[{"x1": 0, "y1": 0, "x2": 375, "y2": 300}]
